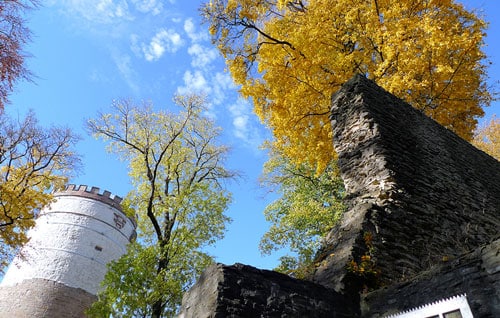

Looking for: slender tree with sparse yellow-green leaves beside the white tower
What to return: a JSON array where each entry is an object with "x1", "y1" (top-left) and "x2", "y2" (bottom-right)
[{"x1": 88, "y1": 95, "x2": 235, "y2": 317}]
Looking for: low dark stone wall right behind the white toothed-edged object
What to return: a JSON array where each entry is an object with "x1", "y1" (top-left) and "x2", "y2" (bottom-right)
[{"x1": 361, "y1": 240, "x2": 500, "y2": 318}]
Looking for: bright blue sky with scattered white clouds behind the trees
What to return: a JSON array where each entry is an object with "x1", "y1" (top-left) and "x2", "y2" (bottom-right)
[{"x1": 6, "y1": 0, "x2": 500, "y2": 269}]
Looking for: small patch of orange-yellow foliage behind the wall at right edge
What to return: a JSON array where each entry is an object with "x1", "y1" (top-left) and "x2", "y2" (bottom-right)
[{"x1": 472, "y1": 116, "x2": 500, "y2": 160}]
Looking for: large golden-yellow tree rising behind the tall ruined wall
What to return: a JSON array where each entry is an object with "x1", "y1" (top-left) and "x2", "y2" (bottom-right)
[{"x1": 202, "y1": 0, "x2": 491, "y2": 171}]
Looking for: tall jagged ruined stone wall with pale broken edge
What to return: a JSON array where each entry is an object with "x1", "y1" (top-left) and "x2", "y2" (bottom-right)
[{"x1": 312, "y1": 75, "x2": 500, "y2": 294}]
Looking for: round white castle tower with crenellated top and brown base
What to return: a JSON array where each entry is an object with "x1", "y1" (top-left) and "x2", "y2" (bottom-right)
[{"x1": 0, "y1": 185, "x2": 136, "y2": 318}]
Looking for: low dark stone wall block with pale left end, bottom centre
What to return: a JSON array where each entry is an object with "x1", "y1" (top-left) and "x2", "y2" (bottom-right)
[{"x1": 178, "y1": 264, "x2": 357, "y2": 318}]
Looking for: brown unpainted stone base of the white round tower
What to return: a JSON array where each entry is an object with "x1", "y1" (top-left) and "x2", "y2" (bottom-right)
[{"x1": 0, "y1": 279, "x2": 97, "y2": 318}]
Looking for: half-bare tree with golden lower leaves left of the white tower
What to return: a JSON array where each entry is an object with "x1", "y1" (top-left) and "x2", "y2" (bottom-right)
[{"x1": 0, "y1": 112, "x2": 80, "y2": 269}]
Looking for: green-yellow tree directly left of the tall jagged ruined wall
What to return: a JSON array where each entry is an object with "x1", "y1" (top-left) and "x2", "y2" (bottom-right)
[{"x1": 260, "y1": 147, "x2": 344, "y2": 278}]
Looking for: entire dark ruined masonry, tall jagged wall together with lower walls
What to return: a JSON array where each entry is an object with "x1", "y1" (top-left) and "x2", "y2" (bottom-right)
[{"x1": 181, "y1": 75, "x2": 500, "y2": 318}]
